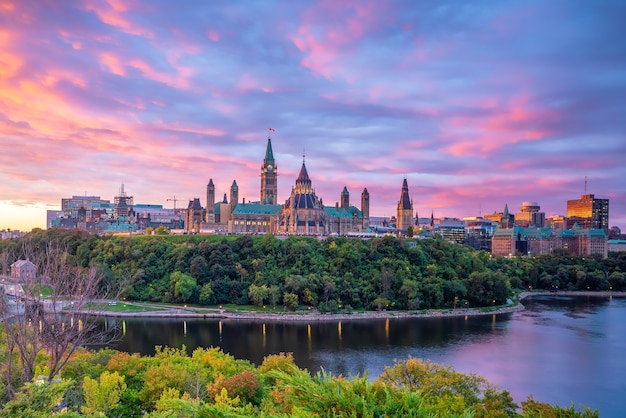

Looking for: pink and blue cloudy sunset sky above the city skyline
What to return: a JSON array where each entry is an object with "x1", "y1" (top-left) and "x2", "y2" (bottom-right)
[{"x1": 0, "y1": 0, "x2": 626, "y2": 231}]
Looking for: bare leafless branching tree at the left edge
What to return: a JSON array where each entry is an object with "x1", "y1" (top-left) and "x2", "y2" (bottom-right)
[{"x1": 0, "y1": 233, "x2": 110, "y2": 397}]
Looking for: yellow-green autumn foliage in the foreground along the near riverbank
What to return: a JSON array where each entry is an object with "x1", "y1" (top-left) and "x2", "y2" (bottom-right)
[{"x1": 0, "y1": 342, "x2": 599, "y2": 418}]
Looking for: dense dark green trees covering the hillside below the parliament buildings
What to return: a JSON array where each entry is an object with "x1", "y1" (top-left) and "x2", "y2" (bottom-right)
[{"x1": 0, "y1": 230, "x2": 626, "y2": 312}]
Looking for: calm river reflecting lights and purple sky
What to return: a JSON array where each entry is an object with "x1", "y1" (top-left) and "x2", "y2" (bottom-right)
[{"x1": 112, "y1": 295, "x2": 626, "y2": 417}]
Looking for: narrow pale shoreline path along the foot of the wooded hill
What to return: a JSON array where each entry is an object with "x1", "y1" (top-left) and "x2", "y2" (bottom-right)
[{"x1": 87, "y1": 291, "x2": 626, "y2": 322}]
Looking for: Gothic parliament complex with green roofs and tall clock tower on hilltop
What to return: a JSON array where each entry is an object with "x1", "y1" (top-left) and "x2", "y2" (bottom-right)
[{"x1": 185, "y1": 136, "x2": 370, "y2": 235}]
